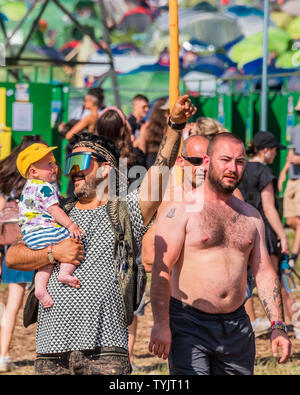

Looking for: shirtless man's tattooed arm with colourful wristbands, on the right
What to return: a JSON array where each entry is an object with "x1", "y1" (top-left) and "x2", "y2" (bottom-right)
[{"x1": 249, "y1": 218, "x2": 291, "y2": 363}]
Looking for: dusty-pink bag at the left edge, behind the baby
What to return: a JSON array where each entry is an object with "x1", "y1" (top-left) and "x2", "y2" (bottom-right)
[{"x1": 0, "y1": 200, "x2": 20, "y2": 245}]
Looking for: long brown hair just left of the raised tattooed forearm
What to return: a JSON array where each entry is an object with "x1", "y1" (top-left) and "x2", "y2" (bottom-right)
[{"x1": 147, "y1": 97, "x2": 167, "y2": 153}]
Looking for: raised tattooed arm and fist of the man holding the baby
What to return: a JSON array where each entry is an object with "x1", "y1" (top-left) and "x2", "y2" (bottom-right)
[{"x1": 139, "y1": 95, "x2": 196, "y2": 225}]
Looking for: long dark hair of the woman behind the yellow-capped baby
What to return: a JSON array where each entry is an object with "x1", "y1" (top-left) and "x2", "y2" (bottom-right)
[{"x1": 0, "y1": 135, "x2": 48, "y2": 199}]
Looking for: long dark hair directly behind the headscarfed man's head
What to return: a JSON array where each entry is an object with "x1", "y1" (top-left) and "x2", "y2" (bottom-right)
[{"x1": 96, "y1": 109, "x2": 136, "y2": 167}]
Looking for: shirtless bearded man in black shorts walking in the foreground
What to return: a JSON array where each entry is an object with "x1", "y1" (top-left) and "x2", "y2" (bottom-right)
[{"x1": 149, "y1": 133, "x2": 291, "y2": 374}]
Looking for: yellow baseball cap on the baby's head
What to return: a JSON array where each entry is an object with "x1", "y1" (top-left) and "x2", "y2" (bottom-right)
[{"x1": 17, "y1": 143, "x2": 57, "y2": 178}]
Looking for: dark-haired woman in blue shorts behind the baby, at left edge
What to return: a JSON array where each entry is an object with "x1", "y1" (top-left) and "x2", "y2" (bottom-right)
[{"x1": 0, "y1": 135, "x2": 46, "y2": 372}]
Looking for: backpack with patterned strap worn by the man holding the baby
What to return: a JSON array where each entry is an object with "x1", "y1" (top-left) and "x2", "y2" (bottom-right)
[{"x1": 106, "y1": 197, "x2": 147, "y2": 325}]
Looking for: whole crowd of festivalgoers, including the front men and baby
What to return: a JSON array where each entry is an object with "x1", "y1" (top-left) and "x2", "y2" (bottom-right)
[{"x1": 0, "y1": 88, "x2": 300, "y2": 375}]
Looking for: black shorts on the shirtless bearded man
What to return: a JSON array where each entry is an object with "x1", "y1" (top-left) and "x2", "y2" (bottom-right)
[{"x1": 169, "y1": 298, "x2": 255, "y2": 375}]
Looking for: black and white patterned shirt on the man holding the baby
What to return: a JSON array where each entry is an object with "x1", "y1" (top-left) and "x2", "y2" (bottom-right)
[{"x1": 36, "y1": 190, "x2": 148, "y2": 354}]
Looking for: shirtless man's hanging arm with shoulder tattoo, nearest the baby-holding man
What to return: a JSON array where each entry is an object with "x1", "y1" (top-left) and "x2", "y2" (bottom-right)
[{"x1": 149, "y1": 202, "x2": 186, "y2": 359}]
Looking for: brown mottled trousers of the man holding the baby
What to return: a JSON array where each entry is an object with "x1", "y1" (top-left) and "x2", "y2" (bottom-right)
[{"x1": 35, "y1": 347, "x2": 131, "y2": 375}]
